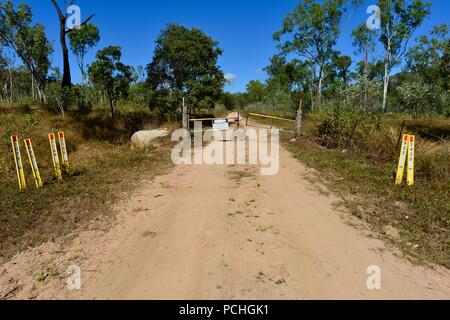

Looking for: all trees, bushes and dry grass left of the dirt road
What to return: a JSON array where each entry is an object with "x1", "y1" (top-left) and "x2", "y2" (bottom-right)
[{"x1": 0, "y1": 0, "x2": 229, "y2": 262}]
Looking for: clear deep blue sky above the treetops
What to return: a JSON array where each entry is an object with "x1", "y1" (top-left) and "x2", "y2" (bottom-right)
[{"x1": 25, "y1": 0, "x2": 450, "y2": 92}]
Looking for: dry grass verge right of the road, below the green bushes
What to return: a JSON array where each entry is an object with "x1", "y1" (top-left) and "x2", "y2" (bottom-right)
[{"x1": 285, "y1": 114, "x2": 450, "y2": 267}]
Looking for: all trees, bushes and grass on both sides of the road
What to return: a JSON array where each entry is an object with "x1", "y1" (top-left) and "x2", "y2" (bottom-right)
[{"x1": 0, "y1": 0, "x2": 450, "y2": 267}]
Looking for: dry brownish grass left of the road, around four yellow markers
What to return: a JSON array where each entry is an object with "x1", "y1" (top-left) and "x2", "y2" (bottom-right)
[{"x1": 0, "y1": 108, "x2": 171, "y2": 261}]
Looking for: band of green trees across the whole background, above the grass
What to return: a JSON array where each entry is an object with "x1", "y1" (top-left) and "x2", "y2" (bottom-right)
[{"x1": 0, "y1": 0, "x2": 450, "y2": 119}]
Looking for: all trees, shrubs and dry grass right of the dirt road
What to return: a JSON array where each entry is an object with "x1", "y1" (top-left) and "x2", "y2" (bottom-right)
[{"x1": 237, "y1": 0, "x2": 450, "y2": 268}]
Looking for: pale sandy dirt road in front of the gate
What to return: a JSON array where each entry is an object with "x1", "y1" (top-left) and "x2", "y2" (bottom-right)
[{"x1": 1, "y1": 124, "x2": 450, "y2": 299}]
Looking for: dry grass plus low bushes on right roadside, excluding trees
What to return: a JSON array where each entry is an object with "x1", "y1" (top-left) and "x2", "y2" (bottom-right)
[{"x1": 285, "y1": 108, "x2": 450, "y2": 267}]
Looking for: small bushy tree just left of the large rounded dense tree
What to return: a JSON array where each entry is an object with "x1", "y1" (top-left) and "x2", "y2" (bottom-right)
[{"x1": 88, "y1": 46, "x2": 132, "y2": 119}]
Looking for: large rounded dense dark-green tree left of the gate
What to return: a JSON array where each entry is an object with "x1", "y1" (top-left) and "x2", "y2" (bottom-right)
[{"x1": 147, "y1": 24, "x2": 225, "y2": 115}]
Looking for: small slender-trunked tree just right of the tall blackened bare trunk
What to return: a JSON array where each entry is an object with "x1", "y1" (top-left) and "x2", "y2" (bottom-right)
[{"x1": 69, "y1": 23, "x2": 100, "y2": 82}]
